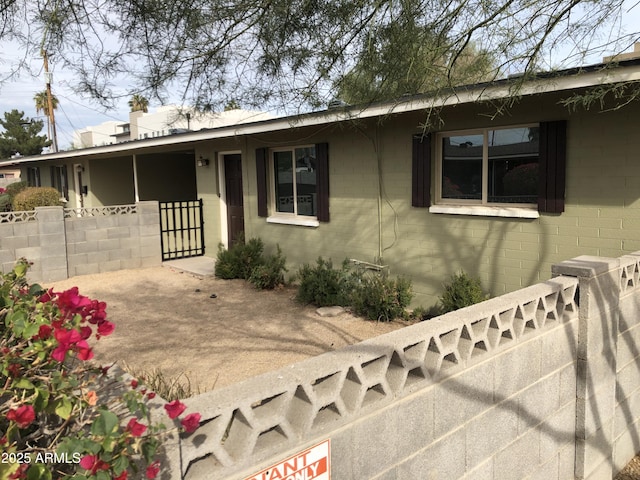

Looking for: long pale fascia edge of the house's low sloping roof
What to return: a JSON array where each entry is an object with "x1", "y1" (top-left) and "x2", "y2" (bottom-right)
[{"x1": 0, "y1": 58, "x2": 640, "y2": 167}]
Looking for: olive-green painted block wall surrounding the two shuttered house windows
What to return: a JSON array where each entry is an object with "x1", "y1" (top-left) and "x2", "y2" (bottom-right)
[{"x1": 197, "y1": 97, "x2": 640, "y2": 307}]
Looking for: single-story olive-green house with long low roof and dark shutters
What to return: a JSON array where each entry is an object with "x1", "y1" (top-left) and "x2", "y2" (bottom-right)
[{"x1": 0, "y1": 53, "x2": 640, "y2": 307}]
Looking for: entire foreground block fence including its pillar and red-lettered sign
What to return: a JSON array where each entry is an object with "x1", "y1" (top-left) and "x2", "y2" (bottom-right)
[{"x1": 158, "y1": 253, "x2": 640, "y2": 480}]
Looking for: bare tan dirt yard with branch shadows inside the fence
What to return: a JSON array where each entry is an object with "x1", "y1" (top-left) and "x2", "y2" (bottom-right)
[{"x1": 46, "y1": 267, "x2": 407, "y2": 391}]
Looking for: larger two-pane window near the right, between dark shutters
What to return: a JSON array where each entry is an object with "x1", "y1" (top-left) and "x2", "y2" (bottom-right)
[{"x1": 437, "y1": 125, "x2": 540, "y2": 205}]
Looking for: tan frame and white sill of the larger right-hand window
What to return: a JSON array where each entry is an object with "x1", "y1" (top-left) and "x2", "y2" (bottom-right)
[{"x1": 436, "y1": 123, "x2": 541, "y2": 208}]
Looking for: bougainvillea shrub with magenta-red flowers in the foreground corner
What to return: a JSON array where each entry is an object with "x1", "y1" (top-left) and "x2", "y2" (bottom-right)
[{"x1": 0, "y1": 260, "x2": 200, "y2": 480}]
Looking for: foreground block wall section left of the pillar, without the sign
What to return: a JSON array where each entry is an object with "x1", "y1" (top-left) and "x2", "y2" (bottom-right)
[{"x1": 179, "y1": 277, "x2": 578, "y2": 480}]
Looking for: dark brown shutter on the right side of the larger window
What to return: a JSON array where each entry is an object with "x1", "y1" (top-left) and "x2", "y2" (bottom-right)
[{"x1": 538, "y1": 120, "x2": 567, "y2": 213}]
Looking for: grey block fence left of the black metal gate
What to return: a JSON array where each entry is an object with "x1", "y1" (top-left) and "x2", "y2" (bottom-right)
[{"x1": 0, "y1": 201, "x2": 162, "y2": 282}]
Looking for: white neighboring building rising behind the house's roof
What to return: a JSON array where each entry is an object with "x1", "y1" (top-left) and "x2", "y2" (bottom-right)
[{"x1": 73, "y1": 105, "x2": 271, "y2": 148}]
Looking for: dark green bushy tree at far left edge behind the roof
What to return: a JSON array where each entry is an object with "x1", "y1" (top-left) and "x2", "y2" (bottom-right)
[{"x1": 0, "y1": 109, "x2": 51, "y2": 158}]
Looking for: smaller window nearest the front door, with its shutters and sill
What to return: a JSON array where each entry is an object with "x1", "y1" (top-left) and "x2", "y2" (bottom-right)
[{"x1": 256, "y1": 143, "x2": 329, "y2": 225}]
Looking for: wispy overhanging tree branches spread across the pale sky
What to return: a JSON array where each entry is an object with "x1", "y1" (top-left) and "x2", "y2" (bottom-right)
[{"x1": 0, "y1": 0, "x2": 640, "y2": 113}]
